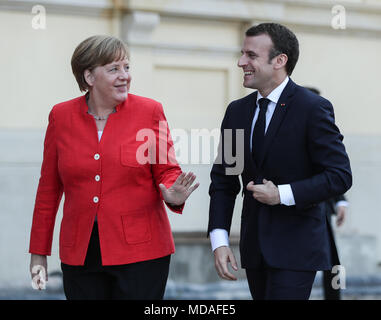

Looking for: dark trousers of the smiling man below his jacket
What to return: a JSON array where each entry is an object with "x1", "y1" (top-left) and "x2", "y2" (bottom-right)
[{"x1": 246, "y1": 257, "x2": 316, "y2": 300}]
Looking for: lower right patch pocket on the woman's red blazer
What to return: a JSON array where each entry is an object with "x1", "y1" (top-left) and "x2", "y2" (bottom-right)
[{"x1": 122, "y1": 209, "x2": 151, "y2": 244}]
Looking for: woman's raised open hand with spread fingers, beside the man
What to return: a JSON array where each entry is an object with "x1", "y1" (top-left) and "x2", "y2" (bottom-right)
[{"x1": 159, "y1": 172, "x2": 200, "y2": 206}]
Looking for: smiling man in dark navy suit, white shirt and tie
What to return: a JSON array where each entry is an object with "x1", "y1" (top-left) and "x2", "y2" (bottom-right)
[{"x1": 208, "y1": 23, "x2": 352, "y2": 299}]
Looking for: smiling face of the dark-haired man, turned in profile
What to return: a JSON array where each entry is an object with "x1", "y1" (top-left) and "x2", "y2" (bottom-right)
[{"x1": 238, "y1": 34, "x2": 275, "y2": 90}]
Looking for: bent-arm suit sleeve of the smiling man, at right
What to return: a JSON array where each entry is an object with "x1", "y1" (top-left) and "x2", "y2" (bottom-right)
[{"x1": 291, "y1": 100, "x2": 352, "y2": 210}]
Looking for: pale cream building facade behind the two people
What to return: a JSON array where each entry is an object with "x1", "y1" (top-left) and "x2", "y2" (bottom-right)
[{"x1": 0, "y1": 0, "x2": 381, "y2": 285}]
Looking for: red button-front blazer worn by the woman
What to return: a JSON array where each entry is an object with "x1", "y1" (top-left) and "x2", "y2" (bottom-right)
[{"x1": 29, "y1": 94, "x2": 183, "y2": 265}]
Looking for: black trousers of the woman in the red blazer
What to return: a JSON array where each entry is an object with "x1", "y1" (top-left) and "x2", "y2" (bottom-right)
[{"x1": 61, "y1": 222, "x2": 170, "y2": 300}]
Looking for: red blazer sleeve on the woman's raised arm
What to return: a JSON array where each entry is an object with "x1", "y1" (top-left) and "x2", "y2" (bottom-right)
[{"x1": 151, "y1": 103, "x2": 184, "y2": 213}]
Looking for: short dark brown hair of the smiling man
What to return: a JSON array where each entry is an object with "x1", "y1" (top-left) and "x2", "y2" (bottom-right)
[{"x1": 246, "y1": 23, "x2": 299, "y2": 76}]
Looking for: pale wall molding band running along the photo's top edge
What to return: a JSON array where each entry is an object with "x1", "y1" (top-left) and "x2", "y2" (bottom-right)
[{"x1": 0, "y1": 0, "x2": 381, "y2": 36}]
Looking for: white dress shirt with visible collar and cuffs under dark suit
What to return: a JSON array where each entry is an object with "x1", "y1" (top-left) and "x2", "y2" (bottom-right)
[{"x1": 209, "y1": 77, "x2": 295, "y2": 251}]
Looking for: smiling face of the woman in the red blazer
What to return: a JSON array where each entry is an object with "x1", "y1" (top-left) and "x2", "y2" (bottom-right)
[{"x1": 85, "y1": 58, "x2": 131, "y2": 105}]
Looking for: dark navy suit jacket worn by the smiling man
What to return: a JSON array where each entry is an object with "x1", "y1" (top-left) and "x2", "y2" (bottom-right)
[{"x1": 208, "y1": 79, "x2": 352, "y2": 270}]
